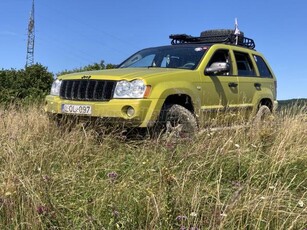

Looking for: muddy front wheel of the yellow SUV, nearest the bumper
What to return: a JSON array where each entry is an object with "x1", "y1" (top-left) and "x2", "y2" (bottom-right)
[{"x1": 155, "y1": 104, "x2": 198, "y2": 138}]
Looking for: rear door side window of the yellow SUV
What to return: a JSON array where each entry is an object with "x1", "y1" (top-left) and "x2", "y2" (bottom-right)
[{"x1": 234, "y1": 52, "x2": 256, "y2": 76}]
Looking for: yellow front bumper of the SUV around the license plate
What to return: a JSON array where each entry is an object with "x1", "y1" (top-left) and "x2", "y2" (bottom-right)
[{"x1": 45, "y1": 95, "x2": 163, "y2": 127}]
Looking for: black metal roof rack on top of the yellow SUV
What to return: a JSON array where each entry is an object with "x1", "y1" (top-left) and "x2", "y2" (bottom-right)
[{"x1": 169, "y1": 33, "x2": 256, "y2": 49}]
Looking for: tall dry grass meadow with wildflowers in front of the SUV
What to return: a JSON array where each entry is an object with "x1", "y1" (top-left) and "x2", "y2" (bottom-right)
[{"x1": 0, "y1": 106, "x2": 307, "y2": 229}]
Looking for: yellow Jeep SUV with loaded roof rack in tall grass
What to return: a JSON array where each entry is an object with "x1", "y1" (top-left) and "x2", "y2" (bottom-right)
[{"x1": 45, "y1": 30, "x2": 277, "y2": 135}]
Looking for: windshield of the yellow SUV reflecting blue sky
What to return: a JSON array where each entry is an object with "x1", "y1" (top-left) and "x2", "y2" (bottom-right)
[{"x1": 119, "y1": 45, "x2": 208, "y2": 70}]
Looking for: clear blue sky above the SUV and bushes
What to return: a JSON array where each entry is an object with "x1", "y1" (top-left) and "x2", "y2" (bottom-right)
[{"x1": 0, "y1": 0, "x2": 307, "y2": 100}]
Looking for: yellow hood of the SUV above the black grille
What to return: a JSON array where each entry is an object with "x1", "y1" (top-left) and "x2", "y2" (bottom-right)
[{"x1": 58, "y1": 67, "x2": 192, "y2": 81}]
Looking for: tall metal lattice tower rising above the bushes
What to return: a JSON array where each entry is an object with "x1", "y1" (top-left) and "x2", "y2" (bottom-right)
[{"x1": 26, "y1": 0, "x2": 35, "y2": 67}]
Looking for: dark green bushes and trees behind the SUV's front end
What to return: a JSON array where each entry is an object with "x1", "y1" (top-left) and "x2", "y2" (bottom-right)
[{"x1": 0, "y1": 61, "x2": 116, "y2": 106}]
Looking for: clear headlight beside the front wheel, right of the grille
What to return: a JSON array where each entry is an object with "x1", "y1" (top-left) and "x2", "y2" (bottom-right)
[{"x1": 113, "y1": 80, "x2": 147, "y2": 98}]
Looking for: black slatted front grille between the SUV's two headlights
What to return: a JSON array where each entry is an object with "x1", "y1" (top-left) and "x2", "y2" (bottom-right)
[{"x1": 60, "y1": 80, "x2": 116, "y2": 101}]
